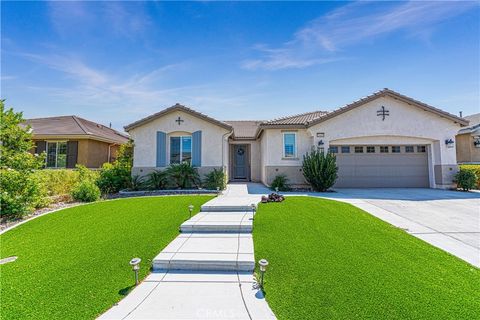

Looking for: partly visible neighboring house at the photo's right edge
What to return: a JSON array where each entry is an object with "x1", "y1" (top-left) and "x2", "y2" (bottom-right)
[{"x1": 456, "y1": 113, "x2": 480, "y2": 164}]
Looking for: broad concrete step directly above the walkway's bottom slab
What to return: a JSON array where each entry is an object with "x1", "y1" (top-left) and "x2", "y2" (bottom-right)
[{"x1": 153, "y1": 233, "x2": 255, "y2": 272}]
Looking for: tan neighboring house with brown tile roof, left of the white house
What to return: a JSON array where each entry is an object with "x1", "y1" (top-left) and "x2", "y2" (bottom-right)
[{"x1": 25, "y1": 116, "x2": 129, "y2": 168}]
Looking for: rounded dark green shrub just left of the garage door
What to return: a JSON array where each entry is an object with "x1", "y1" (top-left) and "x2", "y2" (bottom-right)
[{"x1": 302, "y1": 150, "x2": 338, "y2": 192}]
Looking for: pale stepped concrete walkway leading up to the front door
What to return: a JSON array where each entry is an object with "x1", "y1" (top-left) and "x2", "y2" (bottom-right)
[{"x1": 100, "y1": 184, "x2": 275, "y2": 319}]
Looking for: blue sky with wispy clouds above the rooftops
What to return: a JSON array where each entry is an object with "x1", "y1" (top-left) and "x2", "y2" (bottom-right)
[{"x1": 1, "y1": 2, "x2": 480, "y2": 129}]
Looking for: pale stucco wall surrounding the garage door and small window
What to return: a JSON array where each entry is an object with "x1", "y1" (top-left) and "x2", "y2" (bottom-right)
[{"x1": 261, "y1": 97, "x2": 460, "y2": 188}]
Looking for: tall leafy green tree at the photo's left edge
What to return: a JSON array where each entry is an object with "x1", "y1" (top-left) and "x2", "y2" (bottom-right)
[{"x1": 0, "y1": 100, "x2": 46, "y2": 217}]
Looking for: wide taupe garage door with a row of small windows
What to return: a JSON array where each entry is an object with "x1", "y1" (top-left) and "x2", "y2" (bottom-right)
[{"x1": 330, "y1": 145, "x2": 429, "y2": 188}]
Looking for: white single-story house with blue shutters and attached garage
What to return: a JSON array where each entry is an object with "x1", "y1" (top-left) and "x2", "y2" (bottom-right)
[{"x1": 125, "y1": 89, "x2": 468, "y2": 188}]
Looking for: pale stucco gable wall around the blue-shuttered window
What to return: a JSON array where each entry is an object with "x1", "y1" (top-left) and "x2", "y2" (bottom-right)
[{"x1": 129, "y1": 111, "x2": 229, "y2": 174}]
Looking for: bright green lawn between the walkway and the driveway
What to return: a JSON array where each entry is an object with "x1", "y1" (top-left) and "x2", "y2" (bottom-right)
[{"x1": 254, "y1": 197, "x2": 480, "y2": 319}]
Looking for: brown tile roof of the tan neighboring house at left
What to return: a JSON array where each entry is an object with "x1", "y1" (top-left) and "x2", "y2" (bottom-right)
[{"x1": 24, "y1": 116, "x2": 128, "y2": 143}]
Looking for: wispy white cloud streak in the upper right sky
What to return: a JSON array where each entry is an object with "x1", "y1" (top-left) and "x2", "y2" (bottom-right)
[{"x1": 246, "y1": 1, "x2": 478, "y2": 70}]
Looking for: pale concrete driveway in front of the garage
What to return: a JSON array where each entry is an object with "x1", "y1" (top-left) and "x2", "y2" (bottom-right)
[{"x1": 249, "y1": 185, "x2": 480, "y2": 267}]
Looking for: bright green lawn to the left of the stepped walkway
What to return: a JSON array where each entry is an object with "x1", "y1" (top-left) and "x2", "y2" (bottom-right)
[{"x1": 0, "y1": 196, "x2": 212, "y2": 319}]
